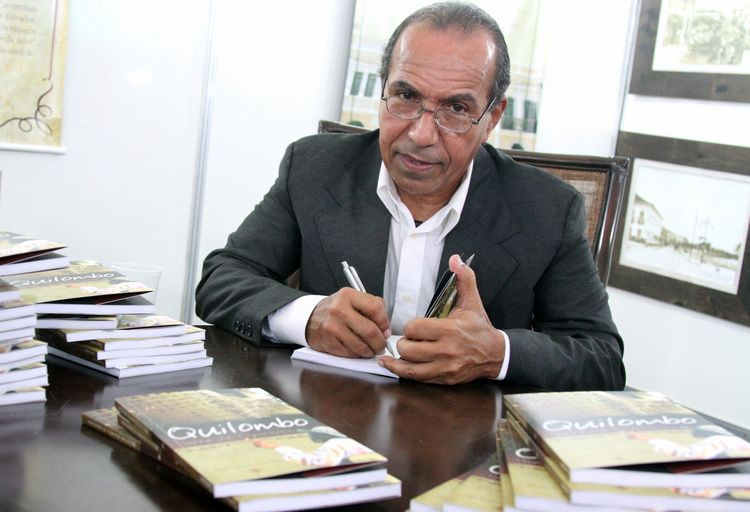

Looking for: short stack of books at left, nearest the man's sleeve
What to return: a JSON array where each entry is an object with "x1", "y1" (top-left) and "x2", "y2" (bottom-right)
[{"x1": 36, "y1": 315, "x2": 213, "y2": 378}]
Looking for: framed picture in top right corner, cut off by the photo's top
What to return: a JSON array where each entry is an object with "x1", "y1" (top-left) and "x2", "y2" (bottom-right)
[{"x1": 630, "y1": 0, "x2": 750, "y2": 102}]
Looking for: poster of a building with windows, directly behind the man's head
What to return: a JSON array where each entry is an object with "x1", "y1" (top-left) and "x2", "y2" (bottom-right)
[{"x1": 340, "y1": 0, "x2": 548, "y2": 151}]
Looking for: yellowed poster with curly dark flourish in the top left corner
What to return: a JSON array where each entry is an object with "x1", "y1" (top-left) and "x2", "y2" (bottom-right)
[{"x1": 0, "y1": 0, "x2": 68, "y2": 152}]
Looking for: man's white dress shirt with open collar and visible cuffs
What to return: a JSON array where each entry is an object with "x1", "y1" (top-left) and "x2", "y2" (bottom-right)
[{"x1": 263, "y1": 161, "x2": 510, "y2": 380}]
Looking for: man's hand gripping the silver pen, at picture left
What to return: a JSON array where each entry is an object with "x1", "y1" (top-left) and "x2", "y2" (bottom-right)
[{"x1": 305, "y1": 287, "x2": 391, "y2": 358}]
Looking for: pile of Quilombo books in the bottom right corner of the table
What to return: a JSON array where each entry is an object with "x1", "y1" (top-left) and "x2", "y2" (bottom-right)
[{"x1": 410, "y1": 391, "x2": 750, "y2": 512}]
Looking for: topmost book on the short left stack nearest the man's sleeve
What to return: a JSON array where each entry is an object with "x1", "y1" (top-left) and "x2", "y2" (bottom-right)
[{"x1": 38, "y1": 315, "x2": 187, "y2": 342}]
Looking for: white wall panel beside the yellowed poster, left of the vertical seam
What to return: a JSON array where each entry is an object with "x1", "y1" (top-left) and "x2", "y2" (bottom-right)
[{"x1": 0, "y1": 0, "x2": 208, "y2": 316}]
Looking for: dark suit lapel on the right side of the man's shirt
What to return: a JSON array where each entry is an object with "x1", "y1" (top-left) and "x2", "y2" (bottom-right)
[{"x1": 438, "y1": 148, "x2": 521, "y2": 306}]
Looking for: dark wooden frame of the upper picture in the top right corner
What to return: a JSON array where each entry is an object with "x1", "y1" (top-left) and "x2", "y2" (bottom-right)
[{"x1": 630, "y1": 0, "x2": 750, "y2": 102}]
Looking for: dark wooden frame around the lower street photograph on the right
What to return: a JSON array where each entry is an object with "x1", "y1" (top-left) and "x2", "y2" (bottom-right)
[{"x1": 610, "y1": 132, "x2": 750, "y2": 325}]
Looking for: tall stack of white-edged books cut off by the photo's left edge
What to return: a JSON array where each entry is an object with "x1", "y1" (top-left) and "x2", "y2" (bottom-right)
[{"x1": 0, "y1": 280, "x2": 47, "y2": 405}]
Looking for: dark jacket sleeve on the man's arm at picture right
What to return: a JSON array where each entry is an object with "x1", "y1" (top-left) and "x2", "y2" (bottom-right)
[{"x1": 506, "y1": 194, "x2": 625, "y2": 390}]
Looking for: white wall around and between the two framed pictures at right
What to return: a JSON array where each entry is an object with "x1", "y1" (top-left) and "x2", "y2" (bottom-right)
[{"x1": 537, "y1": 0, "x2": 750, "y2": 428}]
